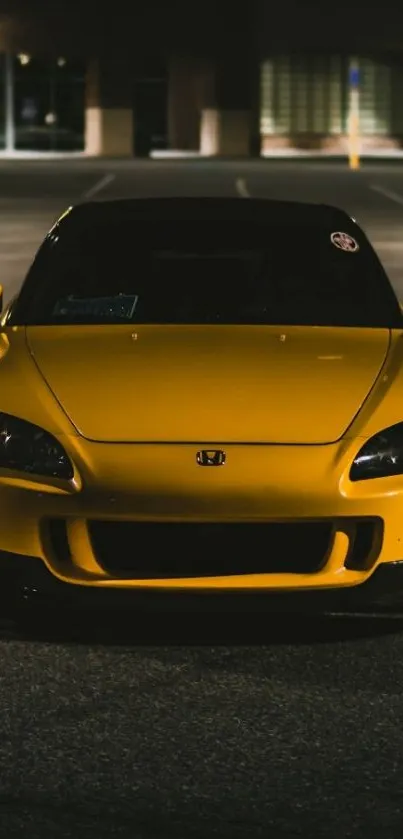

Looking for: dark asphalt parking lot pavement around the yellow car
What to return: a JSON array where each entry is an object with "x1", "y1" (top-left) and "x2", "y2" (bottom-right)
[{"x1": 0, "y1": 161, "x2": 403, "y2": 839}]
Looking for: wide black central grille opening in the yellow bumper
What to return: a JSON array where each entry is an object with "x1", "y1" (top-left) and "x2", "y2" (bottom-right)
[{"x1": 88, "y1": 521, "x2": 333, "y2": 579}]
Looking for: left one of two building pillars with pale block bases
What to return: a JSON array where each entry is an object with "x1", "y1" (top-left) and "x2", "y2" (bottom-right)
[{"x1": 85, "y1": 59, "x2": 134, "y2": 157}]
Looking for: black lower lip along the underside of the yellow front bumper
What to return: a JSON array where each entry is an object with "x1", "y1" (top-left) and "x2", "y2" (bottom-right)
[{"x1": 0, "y1": 553, "x2": 403, "y2": 616}]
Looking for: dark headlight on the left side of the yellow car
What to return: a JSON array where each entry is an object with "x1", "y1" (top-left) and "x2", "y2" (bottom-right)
[{"x1": 0, "y1": 413, "x2": 74, "y2": 480}]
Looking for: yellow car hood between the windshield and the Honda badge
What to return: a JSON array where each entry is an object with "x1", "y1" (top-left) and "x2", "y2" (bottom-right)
[{"x1": 26, "y1": 325, "x2": 390, "y2": 444}]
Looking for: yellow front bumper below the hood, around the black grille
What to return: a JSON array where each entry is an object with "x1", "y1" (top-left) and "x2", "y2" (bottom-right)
[{"x1": 0, "y1": 440, "x2": 403, "y2": 592}]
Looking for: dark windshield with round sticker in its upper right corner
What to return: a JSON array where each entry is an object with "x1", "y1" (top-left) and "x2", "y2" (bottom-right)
[{"x1": 10, "y1": 220, "x2": 402, "y2": 327}]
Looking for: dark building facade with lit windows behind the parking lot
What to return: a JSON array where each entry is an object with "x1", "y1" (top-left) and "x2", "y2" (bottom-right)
[{"x1": 0, "y1": 0, "x2": 403, "y2": 157}]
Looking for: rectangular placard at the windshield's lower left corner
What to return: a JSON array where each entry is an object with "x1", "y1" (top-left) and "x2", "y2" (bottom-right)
[{"x1": 53, "y1": 294, "x2": 139, "y2": 320}]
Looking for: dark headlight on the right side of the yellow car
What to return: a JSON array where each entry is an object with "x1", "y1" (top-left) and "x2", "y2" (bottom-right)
[{"x1": 350, "y1": 422, "x2": 403, "y2": 481}]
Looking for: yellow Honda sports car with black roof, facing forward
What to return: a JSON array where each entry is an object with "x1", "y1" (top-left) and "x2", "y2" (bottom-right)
[{"x1": 0, "y1": 198, "x2": 403, "y2": 608}]
